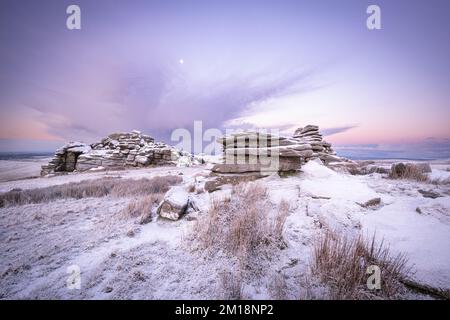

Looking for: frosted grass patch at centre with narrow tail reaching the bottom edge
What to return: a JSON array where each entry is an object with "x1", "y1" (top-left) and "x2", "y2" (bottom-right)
[{"x1": 192, "y1": 183, "x2": 289, "y2": 299}]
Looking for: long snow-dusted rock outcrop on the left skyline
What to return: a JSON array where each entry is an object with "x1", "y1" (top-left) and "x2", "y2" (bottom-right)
[{"x1": 41, "y1": 130, "x2": 183, "y2": 175}]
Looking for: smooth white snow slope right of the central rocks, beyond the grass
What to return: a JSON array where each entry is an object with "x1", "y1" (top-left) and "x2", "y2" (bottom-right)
[{"x1": 300, "y1": 162, "x2": 450, "y2": 289}]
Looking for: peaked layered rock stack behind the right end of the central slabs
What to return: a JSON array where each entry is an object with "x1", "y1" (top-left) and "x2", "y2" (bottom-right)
[{"x1": 293, "y1": 125, "x2": 344, "y2": 164}]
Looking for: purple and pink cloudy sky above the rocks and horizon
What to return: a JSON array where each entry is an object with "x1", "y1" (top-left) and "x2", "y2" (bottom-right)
[{"x1": 0, "y1": 0, "x2": 450, "y2": 157}]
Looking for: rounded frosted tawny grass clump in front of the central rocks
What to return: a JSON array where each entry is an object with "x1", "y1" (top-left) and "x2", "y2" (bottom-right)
[{"x1": 194, "y1": 183, "x2": 289, "y2": 266}]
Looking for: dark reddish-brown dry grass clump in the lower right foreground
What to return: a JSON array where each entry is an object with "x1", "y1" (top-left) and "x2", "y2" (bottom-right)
[{"x1": 312, "y1": 231, "x2": 411, "y2": 300}]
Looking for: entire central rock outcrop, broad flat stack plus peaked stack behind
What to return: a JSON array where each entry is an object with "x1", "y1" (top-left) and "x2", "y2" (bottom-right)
[{"x1": 205, "y1": 125, "x2": 356, "y2": 192}]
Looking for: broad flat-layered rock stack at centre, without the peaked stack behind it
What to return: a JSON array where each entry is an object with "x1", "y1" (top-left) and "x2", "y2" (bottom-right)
[{"x1": 212, "y1": 131, "x2": 313, "y2": 174}]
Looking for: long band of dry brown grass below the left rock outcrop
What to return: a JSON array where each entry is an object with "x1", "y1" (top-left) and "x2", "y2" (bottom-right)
[{"x1": 0, "y1": 176, "x2": 182, "y2": 207}]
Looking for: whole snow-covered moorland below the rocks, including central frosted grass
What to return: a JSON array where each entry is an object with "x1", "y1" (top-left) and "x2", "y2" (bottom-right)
[{"x1": 0, "y1": 161, "x2": 450, "y2": 299}]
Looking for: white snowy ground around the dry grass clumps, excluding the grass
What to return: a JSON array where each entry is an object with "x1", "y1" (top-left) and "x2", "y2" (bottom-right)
[{"x1": 0, "y1": 162, "x2": 450, "y2": 299}]
